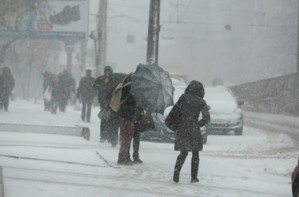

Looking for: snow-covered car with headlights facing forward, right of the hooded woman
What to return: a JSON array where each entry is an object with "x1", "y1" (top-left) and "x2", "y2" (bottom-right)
[{"x1": 202, "y1": 86, "x2": 244, "y2": 135}]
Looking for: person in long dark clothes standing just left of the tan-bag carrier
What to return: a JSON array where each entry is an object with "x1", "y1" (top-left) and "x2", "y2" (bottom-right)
[{"x1": 93, "y1": 66, "x2": 119, "y2": 147}]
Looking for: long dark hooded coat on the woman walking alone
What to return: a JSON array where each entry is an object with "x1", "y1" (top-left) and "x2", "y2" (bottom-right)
[{"x1": 169, "y1": 81, "x2": 210, "y2": 151}]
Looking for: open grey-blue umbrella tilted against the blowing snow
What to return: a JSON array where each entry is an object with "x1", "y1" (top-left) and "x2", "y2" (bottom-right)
[{"x1": 131, "y1": 64, "x2": 174, "y2": 114}]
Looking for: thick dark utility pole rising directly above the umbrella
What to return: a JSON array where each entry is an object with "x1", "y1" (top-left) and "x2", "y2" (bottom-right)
[{"x1": 146, "y1": 0, "x2": 160, "y2": 64}]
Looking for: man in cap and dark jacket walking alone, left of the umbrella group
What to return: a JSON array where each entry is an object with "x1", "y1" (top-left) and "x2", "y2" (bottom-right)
[{"x1": 77, "y1": 69, "x2": 95, "y2": 122}]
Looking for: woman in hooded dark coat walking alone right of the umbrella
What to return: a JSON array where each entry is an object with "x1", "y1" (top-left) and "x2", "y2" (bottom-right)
[{"x1": 166, "y1": 80, "x2": 210, "y2": 183}]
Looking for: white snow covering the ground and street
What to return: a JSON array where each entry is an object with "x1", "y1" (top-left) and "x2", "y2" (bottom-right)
[{"x1": 0, "y1": 100, "x2": 298, "y2": 197}]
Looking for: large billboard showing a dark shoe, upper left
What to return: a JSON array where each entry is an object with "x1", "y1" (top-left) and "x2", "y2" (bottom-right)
[{"x1": 0, "y1": 0, "x2": 89, "y2": 39}]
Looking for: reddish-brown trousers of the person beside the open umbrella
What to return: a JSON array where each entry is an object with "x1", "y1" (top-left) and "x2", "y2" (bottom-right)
[{"x1": 118, "y1": 119, "x2": 134, "y2": 162}]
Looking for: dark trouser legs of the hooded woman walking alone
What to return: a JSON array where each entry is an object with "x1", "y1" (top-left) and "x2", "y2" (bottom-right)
[{"x1": 174, "y1": 151, "x2": 199, "y2": 179}]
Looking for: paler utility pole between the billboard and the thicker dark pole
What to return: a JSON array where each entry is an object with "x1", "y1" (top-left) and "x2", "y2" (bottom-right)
[{"x1": 96, "y1": 0, "x2": 108, "y2": 76}]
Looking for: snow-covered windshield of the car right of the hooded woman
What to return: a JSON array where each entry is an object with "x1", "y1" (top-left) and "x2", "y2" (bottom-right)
[{"x1": 204, "y1": 87, "x2": 237, "y2": 113}]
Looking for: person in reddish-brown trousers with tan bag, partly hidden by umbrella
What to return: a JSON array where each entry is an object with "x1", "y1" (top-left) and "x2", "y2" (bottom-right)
[{"x1": 117, "y1": 75, "x2": 136, "y2": 165}]
